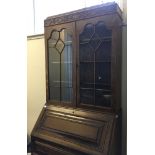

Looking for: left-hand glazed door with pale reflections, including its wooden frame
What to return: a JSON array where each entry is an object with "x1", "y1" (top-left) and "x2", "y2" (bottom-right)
[{"x1": 45, "y1": 23, "x2": 76, "y2": 105}]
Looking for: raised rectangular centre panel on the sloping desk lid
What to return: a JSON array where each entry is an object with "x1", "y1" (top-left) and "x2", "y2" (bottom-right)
[{"x1": 42, "y1": 113, "x2": 104, "y2": 142}]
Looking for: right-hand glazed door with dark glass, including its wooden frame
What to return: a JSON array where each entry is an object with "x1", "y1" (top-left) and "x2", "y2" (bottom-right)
[{"x1": 77, "y1": 16, "x2": 121, "y2": 109}]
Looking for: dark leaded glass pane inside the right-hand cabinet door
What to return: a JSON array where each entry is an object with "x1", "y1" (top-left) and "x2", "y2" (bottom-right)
[{"x1": 79, "y1": 21, "x2": 112, "y2": 107}]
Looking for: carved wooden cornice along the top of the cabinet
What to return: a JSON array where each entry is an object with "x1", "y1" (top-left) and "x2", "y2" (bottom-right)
[{"x1": 44, "y1": 2, "x2": 122, "y2": 27}]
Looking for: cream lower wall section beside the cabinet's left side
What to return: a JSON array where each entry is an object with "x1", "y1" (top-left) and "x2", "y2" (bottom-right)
[{"x1": 27, "y1": 35, "x2": 46, "y2": 135}]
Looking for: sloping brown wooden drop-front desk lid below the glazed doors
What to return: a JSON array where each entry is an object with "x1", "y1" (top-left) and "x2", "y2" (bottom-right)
[{"x1": 34, "y1": 110, "x2": 114, "y2": 155}]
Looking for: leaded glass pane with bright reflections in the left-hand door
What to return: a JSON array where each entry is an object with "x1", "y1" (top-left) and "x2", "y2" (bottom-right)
[{"x1": 48, "y1": 29, "x2": 73, "y2": 102}]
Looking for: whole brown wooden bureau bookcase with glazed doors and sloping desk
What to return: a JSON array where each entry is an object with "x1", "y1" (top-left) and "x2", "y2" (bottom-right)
[{"x1": 32, "y1": 3, "x2": 122, "y2": 155}]
